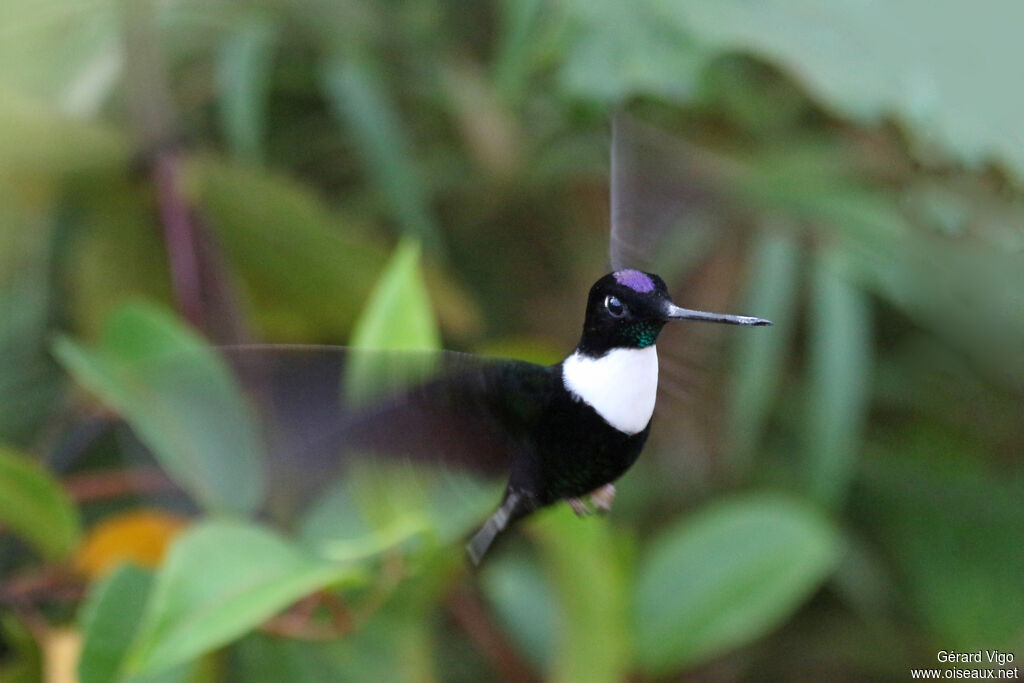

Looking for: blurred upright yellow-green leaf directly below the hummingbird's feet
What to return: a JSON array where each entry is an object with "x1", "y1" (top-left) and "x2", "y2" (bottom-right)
[{"x1": 531, "y1": 506, "x2": 633, "y2": 682}]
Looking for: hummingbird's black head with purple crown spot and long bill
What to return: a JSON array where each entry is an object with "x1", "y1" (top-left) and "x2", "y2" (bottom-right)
[{"x1": 579, "y1": 270, "x2": 771, "y2": 356}]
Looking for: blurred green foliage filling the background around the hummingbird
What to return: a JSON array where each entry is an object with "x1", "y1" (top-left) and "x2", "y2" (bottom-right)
[{"x1": 0, "y1": 0, "x2": 1024, "y2": 682}]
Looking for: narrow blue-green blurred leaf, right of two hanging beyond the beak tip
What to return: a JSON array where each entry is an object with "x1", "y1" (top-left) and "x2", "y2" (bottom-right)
[{"x1": 805, "y1": 251, "x2": 872, "y2": 505}]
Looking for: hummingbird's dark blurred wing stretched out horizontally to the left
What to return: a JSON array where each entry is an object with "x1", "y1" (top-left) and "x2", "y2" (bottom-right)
[{"x1": 222, "y1": 346, "x2": 557, "y2": 511}]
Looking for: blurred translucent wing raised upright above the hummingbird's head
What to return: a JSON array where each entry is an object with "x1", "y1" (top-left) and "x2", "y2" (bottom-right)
[{"x1": 609, "y1": 112, "x2": 713, "y2": 274}]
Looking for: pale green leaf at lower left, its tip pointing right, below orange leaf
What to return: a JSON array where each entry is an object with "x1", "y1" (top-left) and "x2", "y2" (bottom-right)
[{"x1": 125, "y1": 521, "x2": 359, "y2": 675}]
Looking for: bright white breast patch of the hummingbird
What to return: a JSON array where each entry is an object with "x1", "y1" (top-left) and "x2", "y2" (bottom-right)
[{"x1": 562, "y1": 346, "x2": 657, "y2": 434}]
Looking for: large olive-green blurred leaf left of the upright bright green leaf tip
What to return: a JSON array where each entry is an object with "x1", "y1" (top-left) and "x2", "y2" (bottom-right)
[{"x1": 185, "y1": 158, "x2": 387, "y2": 342}]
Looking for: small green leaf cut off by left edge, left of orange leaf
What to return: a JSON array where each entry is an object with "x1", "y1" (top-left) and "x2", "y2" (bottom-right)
[{"x1": 0, "y1": 446, "x2": 81, "y2": 560}]
